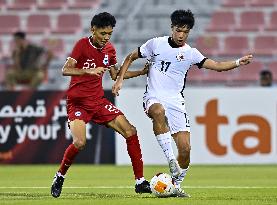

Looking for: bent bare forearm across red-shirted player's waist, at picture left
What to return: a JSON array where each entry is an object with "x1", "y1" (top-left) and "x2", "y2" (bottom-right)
[{"x1": 62, "y1": 58, "x2": 108, "y2": 76}]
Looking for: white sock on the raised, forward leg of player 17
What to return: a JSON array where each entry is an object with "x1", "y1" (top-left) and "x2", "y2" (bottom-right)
[{"x1": 156, "y1": 132, "x2": 176, "y2": 162}]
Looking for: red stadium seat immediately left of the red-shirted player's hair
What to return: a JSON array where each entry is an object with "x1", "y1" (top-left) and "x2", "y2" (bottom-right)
[{"x1": 52, "y1": 14, "x2": 82, "y2": 34}]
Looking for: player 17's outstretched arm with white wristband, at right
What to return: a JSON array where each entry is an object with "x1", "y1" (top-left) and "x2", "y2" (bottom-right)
[{"x1": 203, "y1": 54, "x2": 253, "y2": 72}]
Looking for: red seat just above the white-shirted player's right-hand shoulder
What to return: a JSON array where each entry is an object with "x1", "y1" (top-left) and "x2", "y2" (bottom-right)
[{"x1": 196, "y1": 36, "x2": 219, "y2": 56}]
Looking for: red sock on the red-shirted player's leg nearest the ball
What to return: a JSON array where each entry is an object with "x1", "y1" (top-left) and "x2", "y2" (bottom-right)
[{"x1": 126, "y1": 135, "x2": 143, "y2": 179}]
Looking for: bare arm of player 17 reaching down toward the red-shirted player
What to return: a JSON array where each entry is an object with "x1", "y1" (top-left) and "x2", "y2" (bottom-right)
[{"x1": 112, "y1": 50, "x2": 139, "y2": 96}]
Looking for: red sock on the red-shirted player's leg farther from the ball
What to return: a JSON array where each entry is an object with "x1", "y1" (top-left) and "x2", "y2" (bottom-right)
[{"x1": 59, "y1": 144, "x2": 79, "y2": 175}]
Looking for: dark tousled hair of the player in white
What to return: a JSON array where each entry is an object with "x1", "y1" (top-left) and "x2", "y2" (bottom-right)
[{"x1": 170, "y1": 9, "x2": 194, "y2": 29}]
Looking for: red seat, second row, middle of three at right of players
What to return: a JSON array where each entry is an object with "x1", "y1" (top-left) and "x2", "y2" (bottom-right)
[{"x1": 236, "y1": 11, "x2": 265, "y2": 31}]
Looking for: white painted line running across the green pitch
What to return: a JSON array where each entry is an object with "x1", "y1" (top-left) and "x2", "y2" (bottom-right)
[{"x1": 0, "y1": 186, "x2": 277, "y2": 189}]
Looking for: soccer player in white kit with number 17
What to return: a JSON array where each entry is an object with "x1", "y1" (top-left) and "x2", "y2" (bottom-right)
[{"x1": 112, "y1": 10, "x2": 253, "y2": 197}]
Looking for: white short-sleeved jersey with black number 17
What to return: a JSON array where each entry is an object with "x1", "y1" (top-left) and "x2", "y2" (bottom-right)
[{"x1": 139, "y1": 36, "x2": 205, "y2": 99}]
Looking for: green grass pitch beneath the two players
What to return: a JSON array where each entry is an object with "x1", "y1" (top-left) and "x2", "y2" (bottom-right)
[{"x1": 0, "y1": 165, "x2": 277, "y2": 205}]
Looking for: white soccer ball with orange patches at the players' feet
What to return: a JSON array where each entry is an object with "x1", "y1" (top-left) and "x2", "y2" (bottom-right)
[{"x1": 150, "y1": 173, "x2": 174, "y2": 197}]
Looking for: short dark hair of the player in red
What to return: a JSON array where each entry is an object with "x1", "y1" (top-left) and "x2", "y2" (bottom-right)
[{"x1": 91, "y1": 12, "x2": 116, "y2": 28}]
